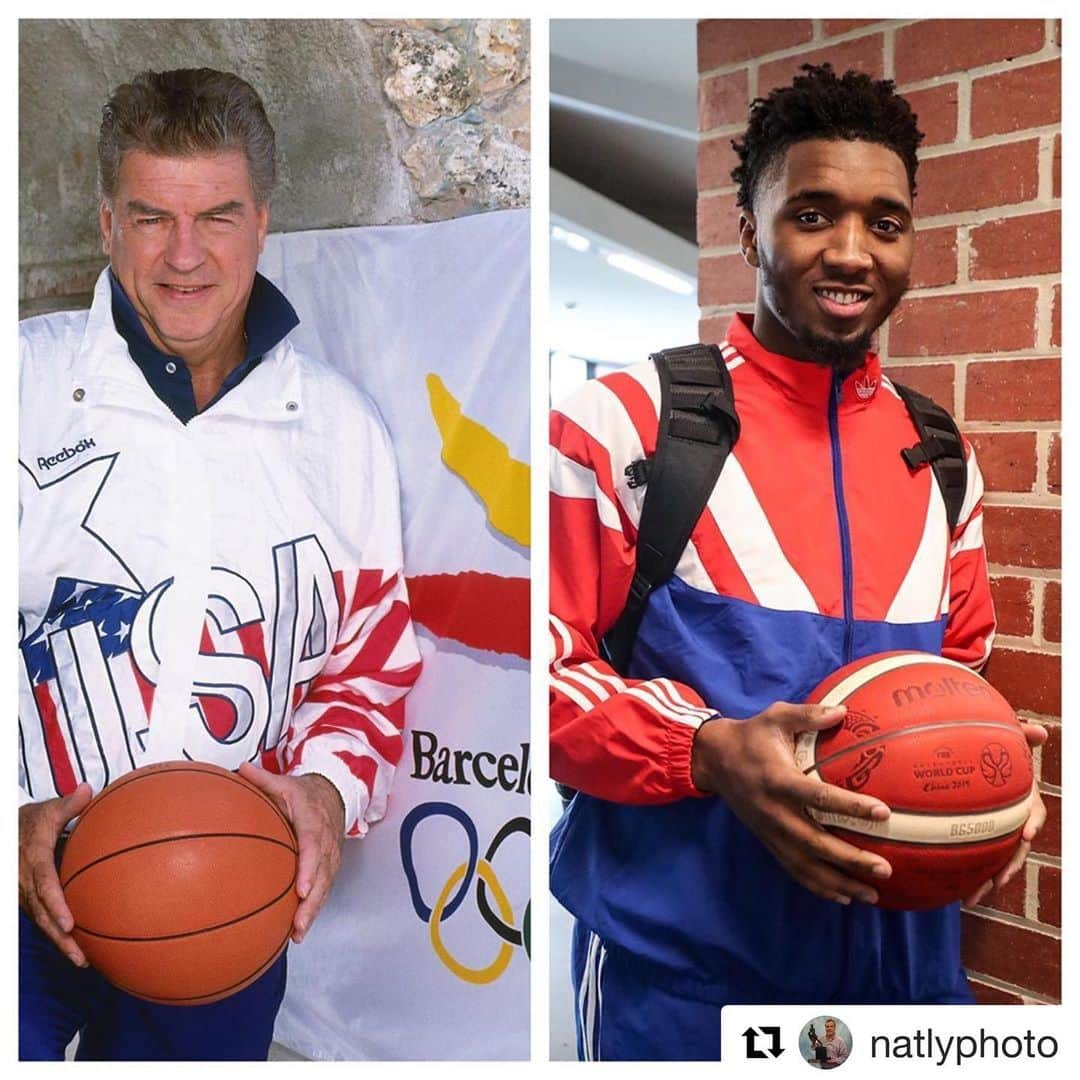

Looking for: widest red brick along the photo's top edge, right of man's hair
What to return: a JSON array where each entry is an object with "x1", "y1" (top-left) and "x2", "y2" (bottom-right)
[{"x1": 895, "y1": 18, "x2": 1043, "y2": 83}]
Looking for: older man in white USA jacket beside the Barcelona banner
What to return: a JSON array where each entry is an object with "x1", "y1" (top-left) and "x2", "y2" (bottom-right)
[{"x1": 19, "y1": 69, "x2": 420, "y2": 1059}]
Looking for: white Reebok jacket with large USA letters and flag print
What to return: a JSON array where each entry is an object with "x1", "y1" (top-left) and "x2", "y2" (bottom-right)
[{"x1": 19, "y1": 267, "x2": 420, "y2": 835}]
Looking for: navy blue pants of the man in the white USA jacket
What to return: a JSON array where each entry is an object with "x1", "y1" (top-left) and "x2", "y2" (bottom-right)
[{"x1": 18, "y1": 909, "x2": 285, "y2": 1062}]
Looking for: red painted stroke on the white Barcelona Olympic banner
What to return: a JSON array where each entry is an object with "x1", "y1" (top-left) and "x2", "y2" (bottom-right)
[{"x1": 406, "y1": 570, "x2": 529, "y2": 656}]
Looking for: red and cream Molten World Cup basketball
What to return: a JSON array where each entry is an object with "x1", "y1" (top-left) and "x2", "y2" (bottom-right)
[{"x1": 795, "y1": 652, "x2": 1034, "y2": 910}]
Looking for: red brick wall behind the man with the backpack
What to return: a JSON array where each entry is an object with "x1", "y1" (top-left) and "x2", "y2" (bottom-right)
[{"x1": 698, "y1": 19, "x2": 1062, "y2": 1003}]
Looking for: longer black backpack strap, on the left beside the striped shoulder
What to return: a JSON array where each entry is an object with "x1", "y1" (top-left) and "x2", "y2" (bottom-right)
[{"x1": 603, "y1": 345, "x2": 739, "y2": 672}]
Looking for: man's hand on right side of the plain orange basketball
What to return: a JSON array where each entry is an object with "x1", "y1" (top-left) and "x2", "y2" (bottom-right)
[{"x1": 240, "y1": 762, "x2": 345, "y2": 945}]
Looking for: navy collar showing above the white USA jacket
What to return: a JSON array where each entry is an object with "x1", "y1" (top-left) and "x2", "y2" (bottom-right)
[{"x1": 109, "y1": 269, "x2": 300, "y2": 423}]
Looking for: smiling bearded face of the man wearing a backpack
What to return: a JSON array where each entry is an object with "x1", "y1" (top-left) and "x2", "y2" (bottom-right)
[{"x1": 740, "y1": 139, "x2": 914, "y2": 372}]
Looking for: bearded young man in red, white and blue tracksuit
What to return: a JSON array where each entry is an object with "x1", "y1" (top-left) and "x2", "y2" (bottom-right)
[{"x1": 551, "y1": 66, "x2": 1044, "y2": 1058}]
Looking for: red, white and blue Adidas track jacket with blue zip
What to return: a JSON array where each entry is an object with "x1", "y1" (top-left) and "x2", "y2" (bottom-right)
[{"x1": 550, "y1": 315, "x2": 995, "y2": 1003}]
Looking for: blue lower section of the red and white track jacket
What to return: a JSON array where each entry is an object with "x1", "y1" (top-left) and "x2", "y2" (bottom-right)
[{"x1": 551, "y1": 579, "x2": 970, "y2": 1003}]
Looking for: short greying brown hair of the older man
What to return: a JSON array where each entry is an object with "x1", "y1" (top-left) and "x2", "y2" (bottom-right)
[{"x1": 97, "y1": 68, "x2": 276, "y2": 206}]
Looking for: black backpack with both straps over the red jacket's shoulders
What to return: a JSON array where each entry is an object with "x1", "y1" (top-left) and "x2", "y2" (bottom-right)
[{"x1": 600, "y1": 345, "x2": 968, "y2": 673}]
